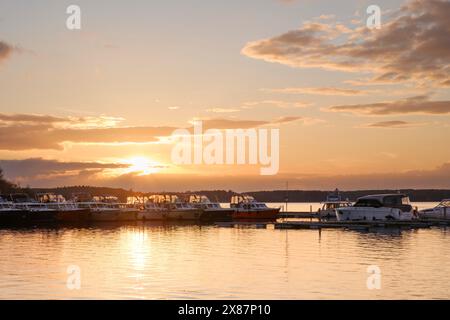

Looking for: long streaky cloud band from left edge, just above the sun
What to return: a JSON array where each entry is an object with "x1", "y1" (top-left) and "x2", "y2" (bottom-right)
[{"x1": 0, "y1": 114, "x2": 310, "y2": 151}]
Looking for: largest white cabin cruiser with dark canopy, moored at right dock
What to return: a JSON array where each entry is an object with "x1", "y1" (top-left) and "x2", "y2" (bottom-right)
[{"x1": 336, "y1": 194, "x2": 416, "y2": 221}]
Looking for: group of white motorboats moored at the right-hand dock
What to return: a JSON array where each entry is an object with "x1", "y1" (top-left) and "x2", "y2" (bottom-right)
[{"x1": 318, "y1": 190, "x2": 450, "y2": 221}]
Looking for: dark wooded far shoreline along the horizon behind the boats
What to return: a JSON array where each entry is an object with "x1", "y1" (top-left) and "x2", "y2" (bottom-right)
[{"x1": 0, "y1": 168, "x2": 450, "y2": 202}]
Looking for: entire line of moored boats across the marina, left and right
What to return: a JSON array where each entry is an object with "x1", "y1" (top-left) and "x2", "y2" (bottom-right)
[{"x1": 0, "y1": 189, "x2": 450, "y2": 225}]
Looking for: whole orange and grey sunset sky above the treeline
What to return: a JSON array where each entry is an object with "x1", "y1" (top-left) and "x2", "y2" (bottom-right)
[{"x1": 0, "y1": 0, "x2": 450, "y2": 191}]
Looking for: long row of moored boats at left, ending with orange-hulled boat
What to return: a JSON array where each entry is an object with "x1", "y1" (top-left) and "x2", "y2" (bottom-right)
[{"x1": 0, "y1": 193, "x2": 280, "y2": 224}]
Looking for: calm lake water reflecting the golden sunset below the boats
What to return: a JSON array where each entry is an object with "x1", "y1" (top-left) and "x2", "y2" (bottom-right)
[{"x1": 0, "y1": 204, "x2": 450, "y2": 299}]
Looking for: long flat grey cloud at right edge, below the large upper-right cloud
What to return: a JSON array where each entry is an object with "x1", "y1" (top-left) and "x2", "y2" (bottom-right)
[{"x1": 328, "y1": 96, "x2": 450, "y2": 115}]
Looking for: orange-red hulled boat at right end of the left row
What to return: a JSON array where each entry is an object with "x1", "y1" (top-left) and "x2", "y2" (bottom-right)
[{"x1": 230, "y1": 195, "x2": 280, "y2": 220}]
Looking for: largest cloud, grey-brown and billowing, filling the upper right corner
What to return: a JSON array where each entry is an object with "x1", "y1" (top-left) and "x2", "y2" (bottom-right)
[{"x1": 242, "y1": 0, "x2": 450, "y2": 86}]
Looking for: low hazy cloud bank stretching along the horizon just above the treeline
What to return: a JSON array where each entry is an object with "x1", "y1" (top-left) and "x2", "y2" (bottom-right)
[{"x1": 4, "y1": 160, "x2": 450, "y2": 192}]
